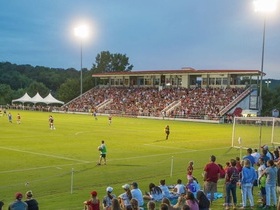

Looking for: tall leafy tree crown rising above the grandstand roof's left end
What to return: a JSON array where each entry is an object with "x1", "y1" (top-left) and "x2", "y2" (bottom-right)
[{"x1": 91, "y1": 51, "x2": 133, "y2": 73}]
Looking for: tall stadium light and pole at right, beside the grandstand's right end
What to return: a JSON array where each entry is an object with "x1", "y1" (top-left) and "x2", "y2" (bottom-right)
[{"x1": 254, "y1": 0, "x2": 278, "y2": 115}]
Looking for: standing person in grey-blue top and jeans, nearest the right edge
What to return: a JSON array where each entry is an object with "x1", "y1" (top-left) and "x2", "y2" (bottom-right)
[{"x1": 263, "y1": 160, "x2": 277, "y2": 208}]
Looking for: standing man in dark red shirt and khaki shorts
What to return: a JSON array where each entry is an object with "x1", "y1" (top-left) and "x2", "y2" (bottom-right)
[{"x1": 204, "y1": 155, "x2": 220, "y2": 203}]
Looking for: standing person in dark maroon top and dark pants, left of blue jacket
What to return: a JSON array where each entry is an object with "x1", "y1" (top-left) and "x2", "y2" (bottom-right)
[{"x1": 225, "y1": 159, "x2": 239, "y2": 209}]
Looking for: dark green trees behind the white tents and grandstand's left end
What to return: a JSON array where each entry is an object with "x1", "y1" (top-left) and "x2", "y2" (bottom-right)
[{"x1": 0, "y1": 51, "x2": 133, "y2": 105}]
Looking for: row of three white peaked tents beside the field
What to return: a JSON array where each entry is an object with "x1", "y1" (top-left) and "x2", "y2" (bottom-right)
[{"x1": 12, "y1": 93, "x2": 64, "y2": 104}]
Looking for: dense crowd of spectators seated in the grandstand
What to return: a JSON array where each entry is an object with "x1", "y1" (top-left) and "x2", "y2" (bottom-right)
[{"x1": 62, "y1": 87, "x2": 244, "y2": 120}]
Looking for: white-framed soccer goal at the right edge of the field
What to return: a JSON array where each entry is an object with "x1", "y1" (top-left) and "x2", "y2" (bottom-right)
[{"x1": 231, "y1": 117, "x2": 280, "y2": 149}]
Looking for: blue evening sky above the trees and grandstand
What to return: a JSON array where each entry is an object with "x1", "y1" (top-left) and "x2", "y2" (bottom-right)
[{"x1": 0, "y1": 0, "x2": 280, "y2": 79}]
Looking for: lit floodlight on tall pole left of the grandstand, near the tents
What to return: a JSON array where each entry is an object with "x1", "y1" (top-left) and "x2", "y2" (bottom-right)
[{"x1": 74, "y1": 25, "x2": 89, "y2": 96}]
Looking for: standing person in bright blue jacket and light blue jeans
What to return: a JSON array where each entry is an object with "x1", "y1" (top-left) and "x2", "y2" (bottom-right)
[{"x1": 241, "y1": 159, "x2": 257, "y2": 209}]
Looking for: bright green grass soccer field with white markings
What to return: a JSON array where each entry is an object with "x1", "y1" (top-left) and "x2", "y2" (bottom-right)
[{"x1": 0, "y1": 110, "x2": 268, "y2": 210}]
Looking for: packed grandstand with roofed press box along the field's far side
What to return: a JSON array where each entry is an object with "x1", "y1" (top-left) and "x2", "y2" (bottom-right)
[{"x1": 62, "y1": 68, "x2": 262, "y2": 122}]
